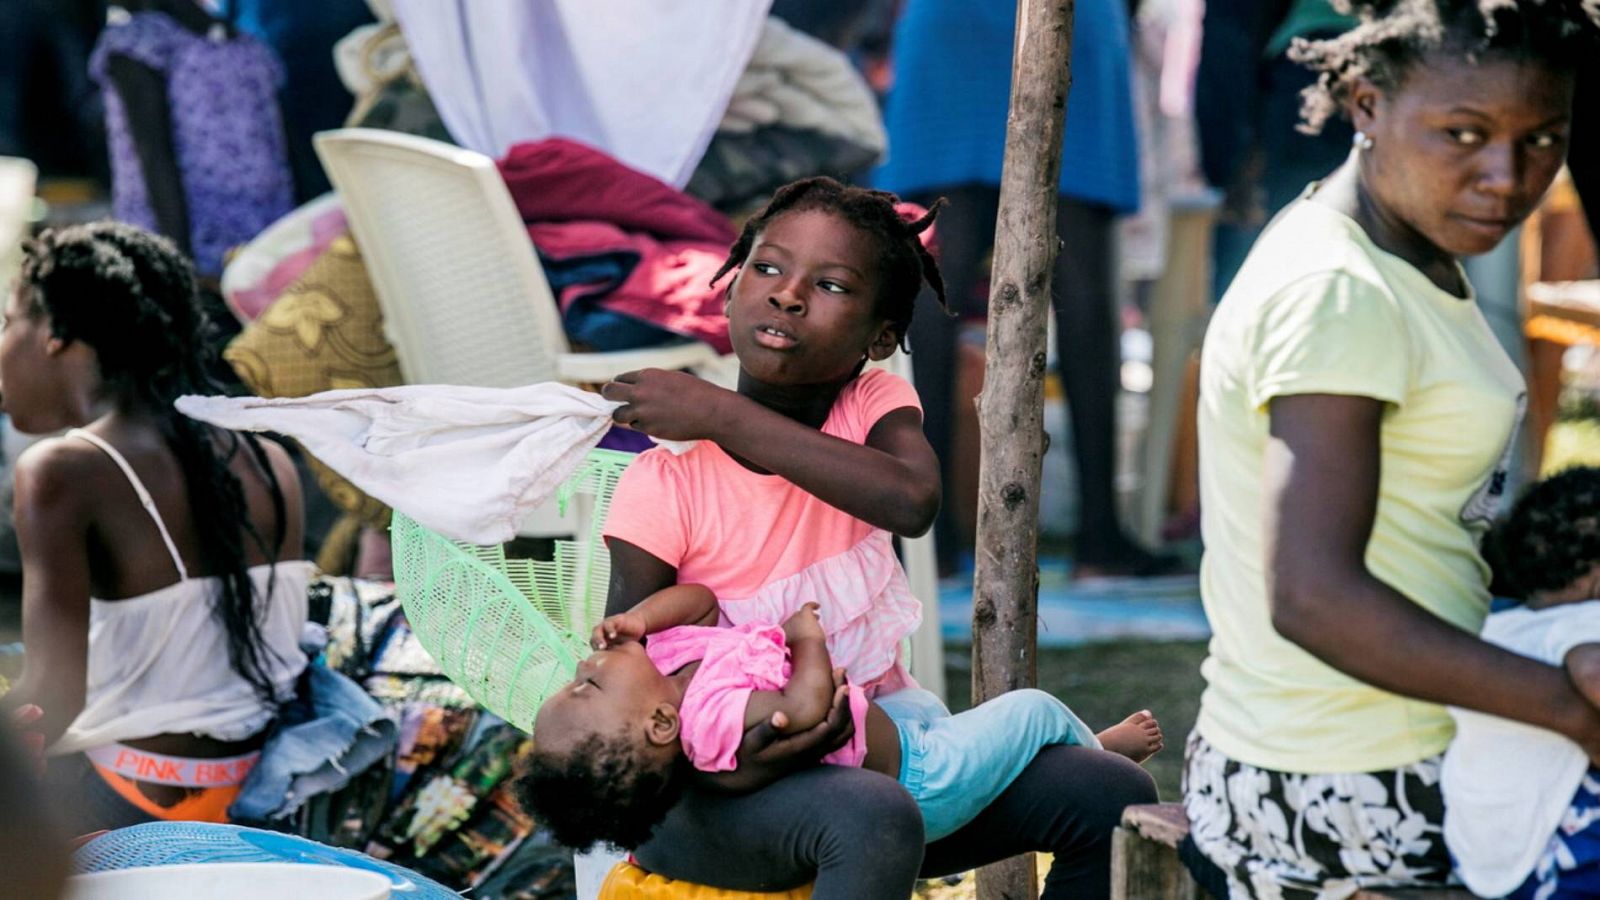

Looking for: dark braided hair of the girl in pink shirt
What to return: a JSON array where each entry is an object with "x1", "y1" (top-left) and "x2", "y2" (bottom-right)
[{"x1": 710, "y1": 176, "x2": 949, "y2": 346}]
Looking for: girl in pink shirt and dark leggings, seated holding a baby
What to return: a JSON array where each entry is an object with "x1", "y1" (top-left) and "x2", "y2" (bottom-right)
[{"x1": 588, "y1": 178, "x2": 1155, "y2": 898}]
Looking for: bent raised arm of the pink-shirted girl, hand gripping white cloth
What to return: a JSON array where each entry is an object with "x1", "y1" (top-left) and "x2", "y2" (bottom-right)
[{"x1": 603, "y1": 368, "x2": 941, "y2": 538}]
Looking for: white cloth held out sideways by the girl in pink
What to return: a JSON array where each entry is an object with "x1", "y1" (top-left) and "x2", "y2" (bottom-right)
[{"x1": 178, "y1": 381, "x2": 688, "y2": 544}]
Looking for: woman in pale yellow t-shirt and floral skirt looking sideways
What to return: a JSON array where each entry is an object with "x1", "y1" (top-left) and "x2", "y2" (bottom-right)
[{"x1": 1186, "y1": 0, "x2": 1600, "y2": 898}]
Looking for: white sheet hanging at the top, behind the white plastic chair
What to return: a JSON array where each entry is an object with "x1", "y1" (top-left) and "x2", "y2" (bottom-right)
[{"x1": 394, "y1": 0, "x2": 771, "y2": 187}]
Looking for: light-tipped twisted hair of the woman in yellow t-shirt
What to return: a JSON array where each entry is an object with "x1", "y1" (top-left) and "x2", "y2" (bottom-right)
[{"x1": 1290, "y1": 0, "x2": 1600, "y2": 135}]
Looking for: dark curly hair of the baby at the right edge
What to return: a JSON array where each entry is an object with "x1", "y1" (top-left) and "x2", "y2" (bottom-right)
[{"x1": 1485, "y1": 466, "x2": 1600, "y2": 599}]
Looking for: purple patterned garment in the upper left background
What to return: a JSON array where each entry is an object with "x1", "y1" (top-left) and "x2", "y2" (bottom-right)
[{"x1": 90, "y1": 11, "x2": 294, "y2": 275}]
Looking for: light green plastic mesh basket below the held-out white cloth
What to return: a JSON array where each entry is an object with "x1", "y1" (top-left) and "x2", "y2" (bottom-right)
[{"x1": 390, "y1": 450, "x2": 634, "y2": 732}]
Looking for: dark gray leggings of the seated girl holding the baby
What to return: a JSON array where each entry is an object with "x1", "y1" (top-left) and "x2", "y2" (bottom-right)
[{"x1": 635, "y1": 746, "x2": 1155, "y2": 900}]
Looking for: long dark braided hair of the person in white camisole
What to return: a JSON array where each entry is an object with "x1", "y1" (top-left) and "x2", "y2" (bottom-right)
[{"x1": 19, "y1": 221, "x2": 288, "y2": 700}]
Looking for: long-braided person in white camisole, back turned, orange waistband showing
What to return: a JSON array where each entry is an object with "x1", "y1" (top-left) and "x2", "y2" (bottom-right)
[{"x1": 0, "y1": 223, "x2": 310, "y2": 830}]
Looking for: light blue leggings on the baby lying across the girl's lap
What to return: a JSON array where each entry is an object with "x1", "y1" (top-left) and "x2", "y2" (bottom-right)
[{"x1": 875, "y1": 687, "x2": 1099, "y2": 842}]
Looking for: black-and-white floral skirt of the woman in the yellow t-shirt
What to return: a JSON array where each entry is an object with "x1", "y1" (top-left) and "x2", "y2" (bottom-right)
[{"x1": 1184, "y1": 732, "x2": 1453, "y2": 900}]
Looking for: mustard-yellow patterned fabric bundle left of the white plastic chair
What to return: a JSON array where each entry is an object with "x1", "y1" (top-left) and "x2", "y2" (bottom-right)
[{"x1": 222, "y1": 235, "x2": 403, "y2": 528}]
